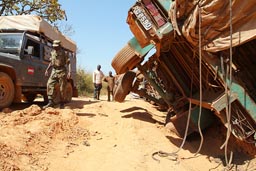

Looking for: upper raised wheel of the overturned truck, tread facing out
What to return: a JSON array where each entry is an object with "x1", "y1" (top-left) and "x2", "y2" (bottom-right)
[{"x1": 111, "y1": 44, "x2": 143, "y2": 74}]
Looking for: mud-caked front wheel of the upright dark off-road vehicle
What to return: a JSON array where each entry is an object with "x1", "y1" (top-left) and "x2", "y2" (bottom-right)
[{"x1": 0, "y1": 72, "x2": 15, "y2": 109}]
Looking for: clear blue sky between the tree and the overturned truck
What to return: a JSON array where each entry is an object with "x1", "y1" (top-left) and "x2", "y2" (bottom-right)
[{"x1": 59, "y1": 0, "x2": 136, "y2": 74}]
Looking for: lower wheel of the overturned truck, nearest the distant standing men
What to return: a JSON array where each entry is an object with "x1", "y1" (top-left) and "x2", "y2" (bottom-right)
[{"x1": 113, "y1": 71, "x2": 136, "y2": 102}]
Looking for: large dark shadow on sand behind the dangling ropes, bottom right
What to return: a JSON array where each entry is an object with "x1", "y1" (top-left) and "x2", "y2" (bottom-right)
[{"x1": 160, "y1": 126, "x2": 256, "y2": 171}]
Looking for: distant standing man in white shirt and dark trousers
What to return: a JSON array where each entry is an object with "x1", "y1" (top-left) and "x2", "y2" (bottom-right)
[{"x1": 92, "y1": 65, "x2": 104, "y2": 100}]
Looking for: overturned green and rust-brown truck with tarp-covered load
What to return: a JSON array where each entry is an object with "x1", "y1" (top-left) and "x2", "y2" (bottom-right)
[{"x1": 112, "y1": 0, "x2": 256, "y2": 152}]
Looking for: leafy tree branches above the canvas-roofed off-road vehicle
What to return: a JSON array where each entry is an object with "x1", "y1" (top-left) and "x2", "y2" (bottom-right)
[{"x1": 0, "y1": 0, "x2": 67, "y2": 23}]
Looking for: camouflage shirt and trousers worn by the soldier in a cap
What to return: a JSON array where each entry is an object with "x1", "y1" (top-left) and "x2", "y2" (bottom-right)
[{"x1": 47, "y1": 49, "x2": 70, "y2": 102}]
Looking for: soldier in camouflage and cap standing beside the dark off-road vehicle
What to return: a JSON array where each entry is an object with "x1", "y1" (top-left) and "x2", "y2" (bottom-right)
[{"x1": 43, "y1": 40, "x2": 71, "y2": 109}]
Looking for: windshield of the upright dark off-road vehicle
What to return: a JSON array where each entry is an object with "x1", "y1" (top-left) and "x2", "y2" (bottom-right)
[{"x1": 0, "y1": 33, "x2": 23, "y2": 54}]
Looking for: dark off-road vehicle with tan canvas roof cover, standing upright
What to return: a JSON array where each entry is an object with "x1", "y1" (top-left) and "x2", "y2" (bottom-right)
[{"x1": 0, "y1": 15, "x2": 78, "y2": 109}]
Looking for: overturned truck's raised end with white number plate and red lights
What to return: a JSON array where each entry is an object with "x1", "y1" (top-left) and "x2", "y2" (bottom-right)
[{"x1": 126, "y1": 0, "x2": 173, "y2": 48}]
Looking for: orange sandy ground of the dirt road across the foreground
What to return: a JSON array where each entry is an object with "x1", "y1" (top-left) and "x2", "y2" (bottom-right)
[{"x1": 0, "y1": 97, "x2": 256, "y2": 171}]
